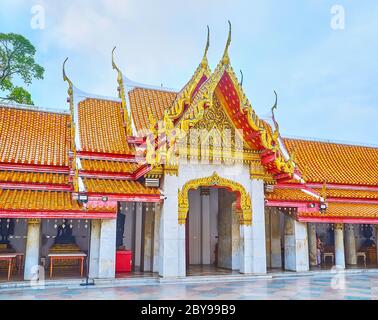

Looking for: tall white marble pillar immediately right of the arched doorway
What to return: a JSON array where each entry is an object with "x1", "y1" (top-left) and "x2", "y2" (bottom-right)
[{"x1": 250, "y1": 179, "x2": 267, "y2": 274}]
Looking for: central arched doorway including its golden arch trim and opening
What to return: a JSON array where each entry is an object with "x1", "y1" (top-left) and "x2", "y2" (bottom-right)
[{"x1": 179, "y1": 173, "x2": 252, "y2": 275}]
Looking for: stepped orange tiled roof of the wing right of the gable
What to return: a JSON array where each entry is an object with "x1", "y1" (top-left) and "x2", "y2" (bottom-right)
[{"x1": 266, "y1": 139, "x2": 378, "y2": 223}]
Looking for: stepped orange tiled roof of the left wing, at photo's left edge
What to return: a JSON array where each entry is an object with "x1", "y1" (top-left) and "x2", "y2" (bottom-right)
[{"x1": 0, "y1": 105, "x2": 114, "y2": 218}]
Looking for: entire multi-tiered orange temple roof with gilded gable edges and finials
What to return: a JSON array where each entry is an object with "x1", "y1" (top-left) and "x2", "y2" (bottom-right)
[{"x1": 0, "y1": 25, "x2": 378, "y2": 222}]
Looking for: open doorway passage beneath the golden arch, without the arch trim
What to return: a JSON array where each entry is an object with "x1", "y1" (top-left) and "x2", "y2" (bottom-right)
[{"x1": 185, "y1": 187, "x2": 240, "y2": 276}]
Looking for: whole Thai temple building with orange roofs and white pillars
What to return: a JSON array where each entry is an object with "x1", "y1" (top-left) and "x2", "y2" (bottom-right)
[{"x1": 0, "y1": 25, "x2": 378, "y2": 281}]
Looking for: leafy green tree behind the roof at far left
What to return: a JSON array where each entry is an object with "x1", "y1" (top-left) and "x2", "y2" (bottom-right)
[{"x1": 0, "y1": 33, "x2": 45, "y2": 104}]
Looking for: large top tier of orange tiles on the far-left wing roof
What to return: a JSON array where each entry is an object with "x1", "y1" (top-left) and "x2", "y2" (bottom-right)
[{"x1": 0, "y1": 106, "x2": 70, "y2": 166}]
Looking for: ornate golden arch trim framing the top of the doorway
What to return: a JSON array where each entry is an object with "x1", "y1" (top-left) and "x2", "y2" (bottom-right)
[{"x1": 178, "y1": 172, "x2": 252, "y2": 225}]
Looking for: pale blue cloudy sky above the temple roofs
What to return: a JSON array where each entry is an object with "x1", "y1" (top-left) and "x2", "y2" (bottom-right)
[{"x1": 0, "y1": 0, "x2": 378, "y2": 144}]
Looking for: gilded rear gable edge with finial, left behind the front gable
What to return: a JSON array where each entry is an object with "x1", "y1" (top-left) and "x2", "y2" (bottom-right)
[{"x1": 168, "y1": 26, "x2": 211, "y2": 122}]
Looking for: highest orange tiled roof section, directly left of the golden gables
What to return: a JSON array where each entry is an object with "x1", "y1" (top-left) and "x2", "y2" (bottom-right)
[{"x1": 129, "y1": 88, "x2": 177, "y2": 131}]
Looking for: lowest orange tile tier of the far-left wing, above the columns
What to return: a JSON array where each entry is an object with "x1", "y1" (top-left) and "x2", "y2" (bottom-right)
[{"x1": 0, "y1": 190, "x2": 82, "y2": 211}]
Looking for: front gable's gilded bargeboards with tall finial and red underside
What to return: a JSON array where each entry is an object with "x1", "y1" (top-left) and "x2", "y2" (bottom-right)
[{"x1": 176, "y1": 22, "x2": 296, "y2": 180}]
